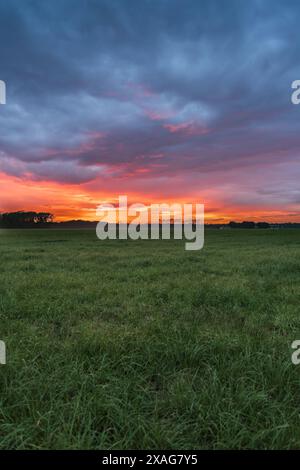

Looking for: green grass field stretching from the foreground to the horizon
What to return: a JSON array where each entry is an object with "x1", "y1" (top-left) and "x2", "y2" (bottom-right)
[{"x1": 0, "y1": 230, "x2": 300, "y2": 449}]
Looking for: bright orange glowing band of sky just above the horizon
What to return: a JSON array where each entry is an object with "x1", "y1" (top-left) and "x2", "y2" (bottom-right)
[{"x1": 0, "y1": 173, "x2": 300, "y2": 223}]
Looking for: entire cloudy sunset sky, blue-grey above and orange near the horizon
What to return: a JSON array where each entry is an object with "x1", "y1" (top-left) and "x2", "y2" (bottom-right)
[{"x1": 0, "y1": 0, "x2": 300, "y2": 223}]
